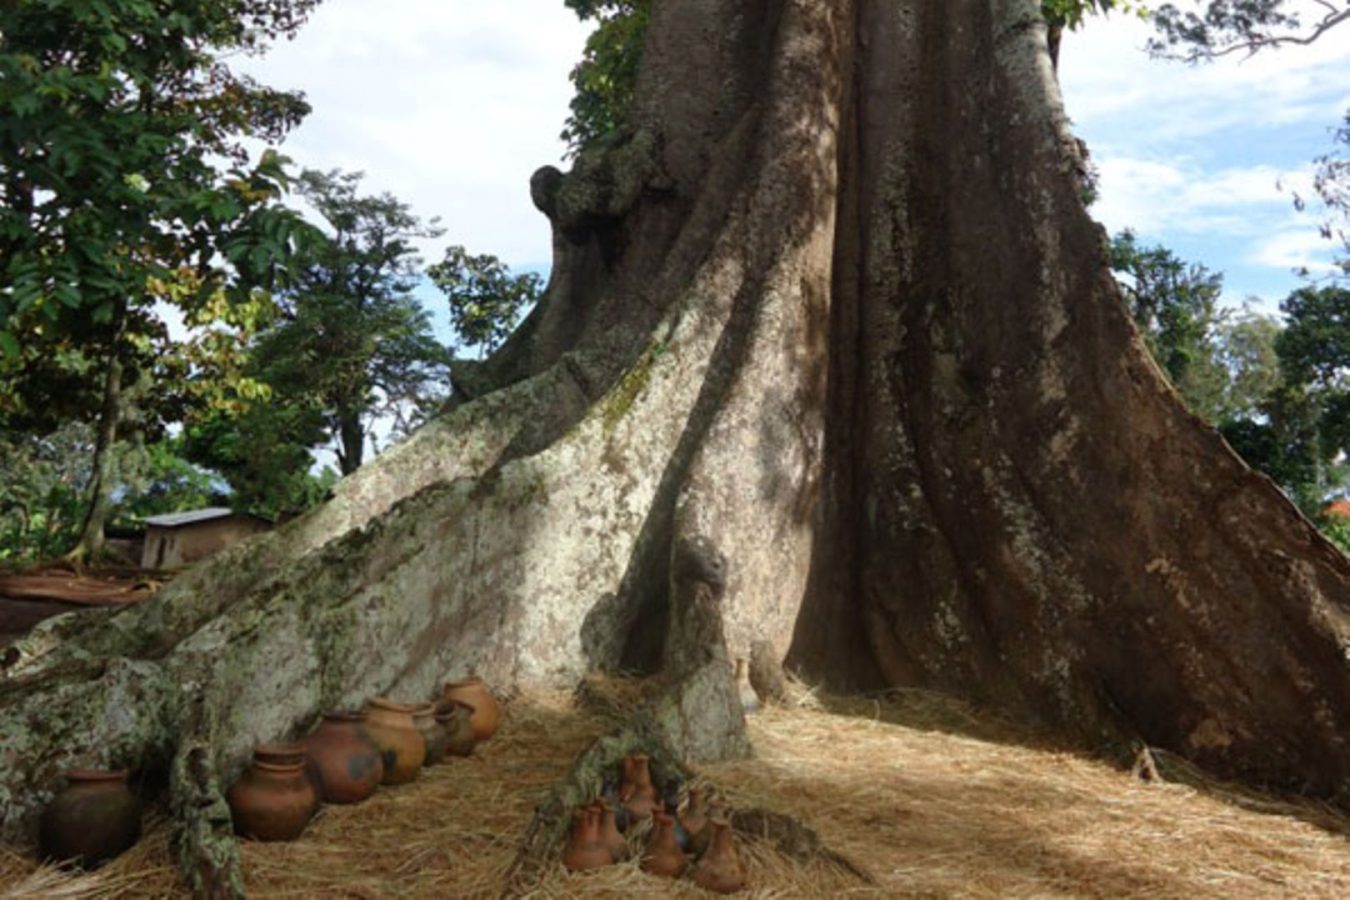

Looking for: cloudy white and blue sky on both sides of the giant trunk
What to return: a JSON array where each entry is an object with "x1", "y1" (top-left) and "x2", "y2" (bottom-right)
[{"x1": 240, "y1": 0, "x2": 1350, "y2": 312}]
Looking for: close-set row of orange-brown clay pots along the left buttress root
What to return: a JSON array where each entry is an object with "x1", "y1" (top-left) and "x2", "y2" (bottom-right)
[{"x1": 227, "y1": 679, "x2": 501, "y2": 841}]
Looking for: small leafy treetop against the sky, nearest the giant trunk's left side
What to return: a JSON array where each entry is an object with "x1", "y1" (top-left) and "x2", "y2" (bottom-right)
[{"x1": 427, "y1": 246, "x2": 544, "y2": 356}]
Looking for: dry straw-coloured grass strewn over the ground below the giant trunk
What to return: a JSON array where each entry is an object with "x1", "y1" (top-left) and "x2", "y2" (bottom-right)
[{"x1": 0, "y1": 685, "x2": 1350, "y2": 899}]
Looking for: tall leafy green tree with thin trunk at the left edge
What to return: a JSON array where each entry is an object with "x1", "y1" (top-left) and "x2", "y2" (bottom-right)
[{"x1": 0, "y1": 0, "x2": 317, "y2": 559}]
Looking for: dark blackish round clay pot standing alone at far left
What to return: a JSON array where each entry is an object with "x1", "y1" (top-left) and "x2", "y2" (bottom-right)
[{"x1": 38, "y1": 770, "x2": 140, "y2": 869}]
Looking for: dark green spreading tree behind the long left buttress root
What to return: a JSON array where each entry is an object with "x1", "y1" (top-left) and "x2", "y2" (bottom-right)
[{"x1": 252, "y1": 170, "x2": 450, "y2": 475}]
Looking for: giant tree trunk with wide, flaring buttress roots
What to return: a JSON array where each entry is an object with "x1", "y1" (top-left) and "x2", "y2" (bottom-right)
[{"x1": 0, "y1": 0, "x2": 1350, "y2": 893}]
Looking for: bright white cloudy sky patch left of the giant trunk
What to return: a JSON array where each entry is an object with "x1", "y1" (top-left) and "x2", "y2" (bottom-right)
[{"x1": 240, "y1": 0, "x2": 586, "y2": 264}]
